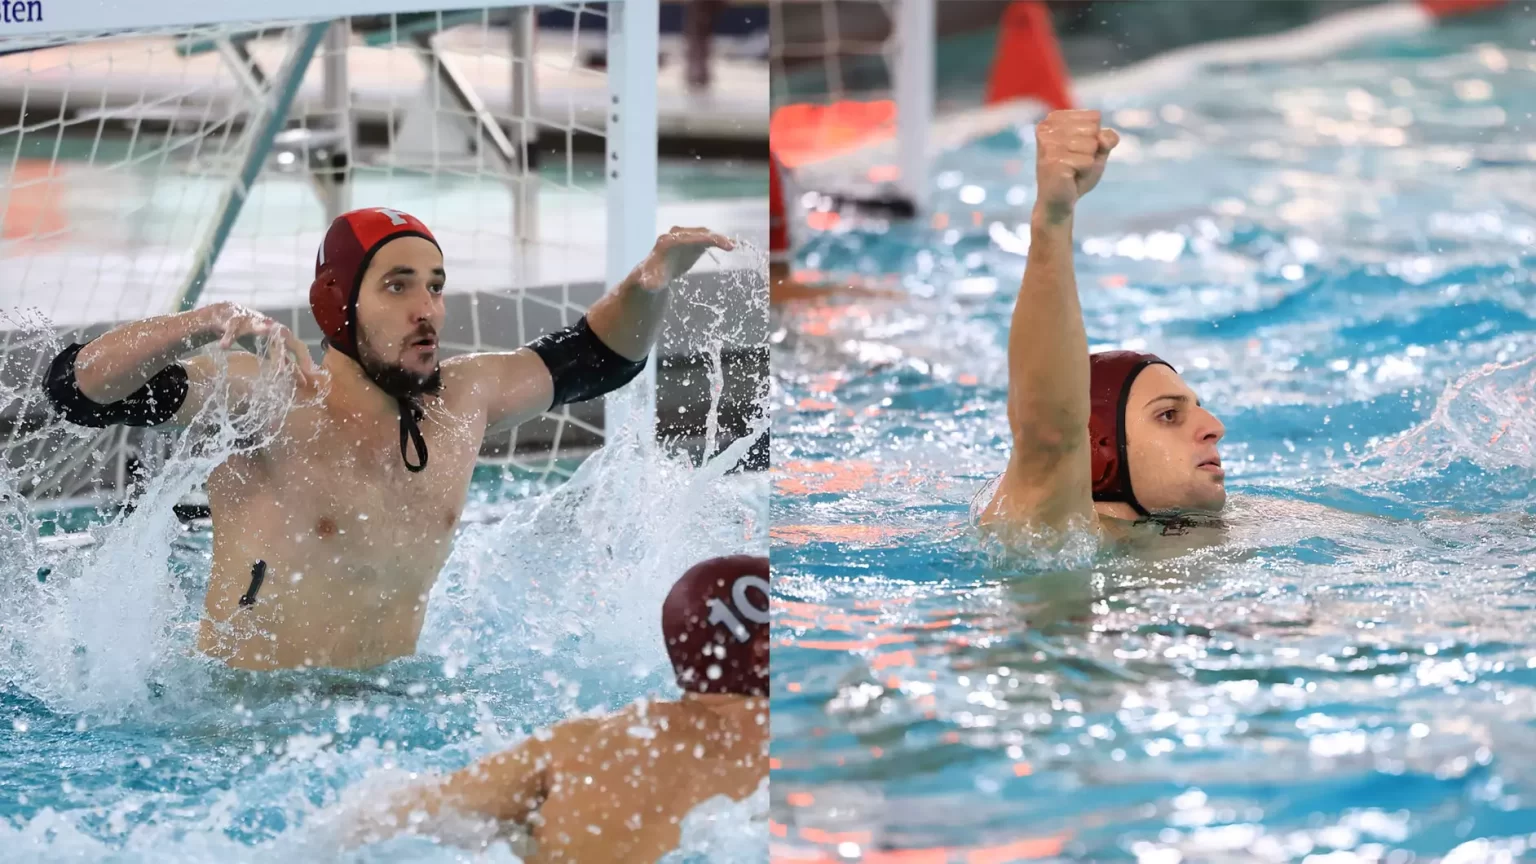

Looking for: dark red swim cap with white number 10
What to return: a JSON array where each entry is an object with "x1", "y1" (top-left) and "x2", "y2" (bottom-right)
[{"x1": 662, "y1": 555, "x2": 768, "y2": 696}]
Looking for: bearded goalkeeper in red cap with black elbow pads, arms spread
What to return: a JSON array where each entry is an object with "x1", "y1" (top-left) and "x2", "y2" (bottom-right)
[{"x1": 48, "y1": 209, "x2": 733, "y2": 669}]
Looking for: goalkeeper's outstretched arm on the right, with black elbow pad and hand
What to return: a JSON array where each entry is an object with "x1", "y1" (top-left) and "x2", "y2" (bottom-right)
[{"x1": 442, "y1": 228, "x2": 736, "y2": 424}]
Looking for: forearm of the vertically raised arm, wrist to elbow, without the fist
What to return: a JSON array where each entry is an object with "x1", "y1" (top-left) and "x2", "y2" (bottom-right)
[{"x1": 1008, "y1": 211, "x2": 1089, "y2": 449}]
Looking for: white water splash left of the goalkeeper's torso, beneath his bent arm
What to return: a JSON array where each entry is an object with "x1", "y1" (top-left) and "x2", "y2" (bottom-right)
[{"x1": 0, "y1": 321, "x2": 295, "y2": 721}]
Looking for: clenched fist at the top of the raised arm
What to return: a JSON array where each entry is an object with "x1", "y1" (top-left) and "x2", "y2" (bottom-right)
[{"x1": 1035, "y1": 111, "x2": 1120, "y2": 223}]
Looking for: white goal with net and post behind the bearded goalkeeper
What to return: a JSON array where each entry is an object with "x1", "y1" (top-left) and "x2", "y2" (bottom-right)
[{"x1": 0, "y1": 0, "x2": 657, "y2": 500}]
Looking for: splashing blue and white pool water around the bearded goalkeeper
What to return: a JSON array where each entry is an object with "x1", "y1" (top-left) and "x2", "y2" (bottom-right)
[{"x1": 0, "y1": 375, "x2": 768, "y2": 864}]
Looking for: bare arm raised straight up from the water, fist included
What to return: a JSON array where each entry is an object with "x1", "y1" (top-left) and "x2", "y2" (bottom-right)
[{"x1": 983, "y1": 111, "x2": 1120, "y2": 529}]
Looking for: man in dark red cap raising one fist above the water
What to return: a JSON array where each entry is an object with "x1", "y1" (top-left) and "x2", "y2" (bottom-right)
[{"x1": 980, "y1": 111, "x2": 1227, "y2": 535}]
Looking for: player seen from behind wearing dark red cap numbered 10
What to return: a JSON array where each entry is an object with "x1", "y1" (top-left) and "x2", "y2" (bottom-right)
[{"x1": 334, "y1": 555, "x2": 768, "y2": 864}]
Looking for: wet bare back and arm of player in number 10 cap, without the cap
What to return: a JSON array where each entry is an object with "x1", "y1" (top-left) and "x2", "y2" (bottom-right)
[{"x1": 350, "y1": 695, "x2": 768, "y2": 864}]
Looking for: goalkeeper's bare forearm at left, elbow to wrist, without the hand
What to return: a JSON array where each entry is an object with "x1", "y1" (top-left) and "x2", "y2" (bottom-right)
[{"x1": 75, "y1": 309, "x2": 218, "y2": 404}]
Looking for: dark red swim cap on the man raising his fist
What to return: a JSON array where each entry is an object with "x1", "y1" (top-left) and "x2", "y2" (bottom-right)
[{"x1": 1087, "y1": 351, "x2": 1177, "y2": 517}]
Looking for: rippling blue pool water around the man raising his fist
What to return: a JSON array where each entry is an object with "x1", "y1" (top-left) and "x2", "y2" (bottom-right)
[{"x1": 771, "y1": 12, "x2": 1536, "y2": 864}]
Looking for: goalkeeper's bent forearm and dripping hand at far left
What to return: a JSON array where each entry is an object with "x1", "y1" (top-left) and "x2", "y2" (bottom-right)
[{"x1": 58, "y1": 303, "x2": 321, "y2": 426}]
